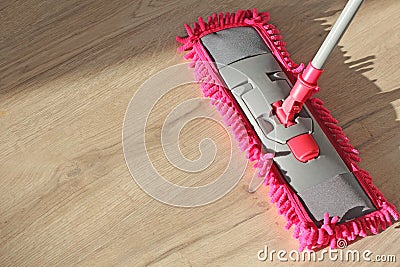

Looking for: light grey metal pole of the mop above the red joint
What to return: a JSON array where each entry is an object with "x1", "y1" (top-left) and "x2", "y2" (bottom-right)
[{"x1": 311, "y1": 0, "x2": 364, "y2": 69}]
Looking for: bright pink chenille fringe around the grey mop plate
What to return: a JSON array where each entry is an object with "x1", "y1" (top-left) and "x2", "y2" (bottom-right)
[{"x1": 176, "y1": 9, "x2": 399, "y2": 251}]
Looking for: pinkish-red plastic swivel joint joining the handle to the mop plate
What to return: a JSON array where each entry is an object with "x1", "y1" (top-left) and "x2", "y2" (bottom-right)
[{"x1": 273, "y1": 62, "x2": 323, "y2": 127}]
